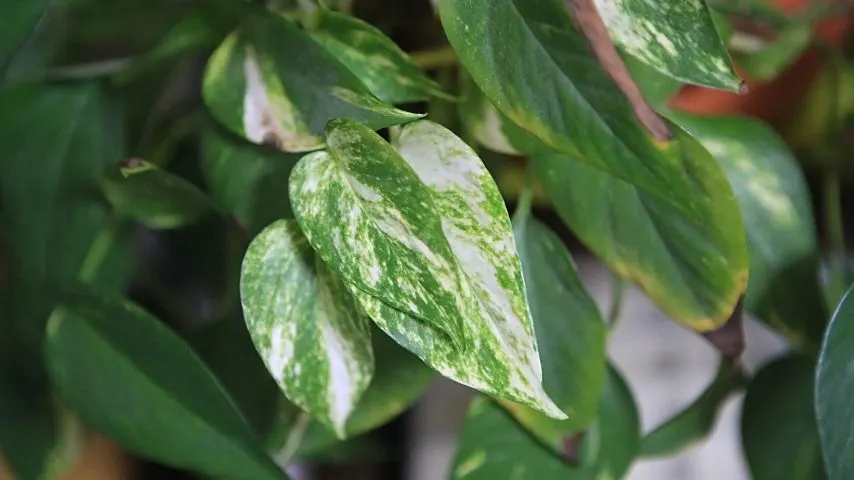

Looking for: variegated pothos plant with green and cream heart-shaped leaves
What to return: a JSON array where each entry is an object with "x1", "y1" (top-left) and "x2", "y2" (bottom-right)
[{"x1": 0, "y1": 0, "x2": 854, "y2": 479}]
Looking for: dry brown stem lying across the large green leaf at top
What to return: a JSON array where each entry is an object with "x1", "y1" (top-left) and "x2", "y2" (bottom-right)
[{"x1": 566, "y1": 0, "x2": 671, "y2": 141}]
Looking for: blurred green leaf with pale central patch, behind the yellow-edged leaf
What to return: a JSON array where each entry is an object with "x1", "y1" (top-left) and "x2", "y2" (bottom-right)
[{"x1": 676, "y1": 115, "x2": 827, "y2": 347}]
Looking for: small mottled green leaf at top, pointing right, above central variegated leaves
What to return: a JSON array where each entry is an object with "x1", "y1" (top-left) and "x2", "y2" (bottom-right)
[{"x1": 311, "y1": 8, "x2": 449, "y2": 103}]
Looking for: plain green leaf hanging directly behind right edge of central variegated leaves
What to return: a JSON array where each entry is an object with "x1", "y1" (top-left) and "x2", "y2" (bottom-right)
[{"x1": 511, "y1": 214, "x2": 606, "y2": 436}]
